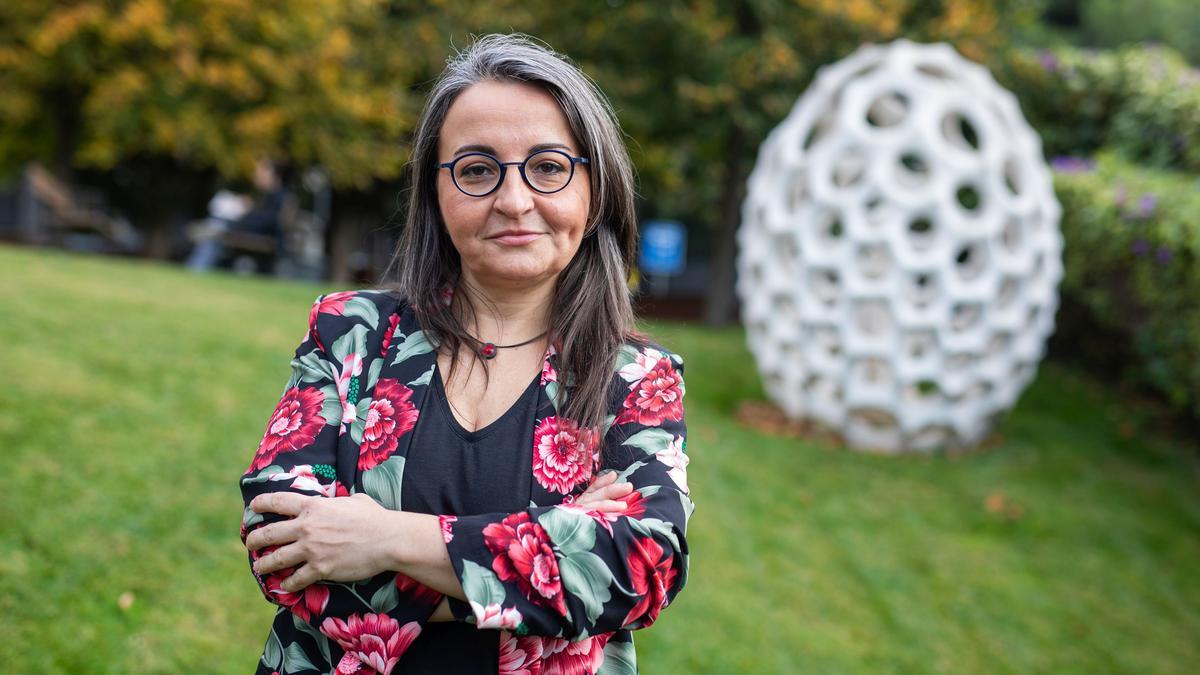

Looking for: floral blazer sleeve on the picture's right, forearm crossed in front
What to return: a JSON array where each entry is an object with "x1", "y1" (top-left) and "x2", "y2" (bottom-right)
[{"x1": 442, "y1": 347, "x2": 694, "y2": 640}]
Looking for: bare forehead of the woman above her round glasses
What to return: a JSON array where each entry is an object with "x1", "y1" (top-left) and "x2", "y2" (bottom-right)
[{"x1": 438, "y1": 80, "x2": 578, "y2": 159}]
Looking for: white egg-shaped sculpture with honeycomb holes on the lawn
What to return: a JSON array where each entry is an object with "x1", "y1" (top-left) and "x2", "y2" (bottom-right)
[{"x1": 738, "y1": 41, "x2": 1062, "y2": 452}]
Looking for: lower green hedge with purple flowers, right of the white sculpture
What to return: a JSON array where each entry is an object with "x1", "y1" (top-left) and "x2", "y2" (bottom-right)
[{"x1": 1055, "y1": 154, "x2": 1200, "y2": 419}]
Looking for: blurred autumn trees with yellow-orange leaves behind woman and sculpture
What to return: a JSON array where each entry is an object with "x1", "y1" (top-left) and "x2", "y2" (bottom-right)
[{"x1": 0, "y1": 0, "x2": 1037, "y2": 285}]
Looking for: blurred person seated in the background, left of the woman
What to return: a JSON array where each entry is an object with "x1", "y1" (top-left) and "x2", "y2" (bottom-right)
[{"x1": 187, "y1": 159, "x2": 290, "y2": 271}]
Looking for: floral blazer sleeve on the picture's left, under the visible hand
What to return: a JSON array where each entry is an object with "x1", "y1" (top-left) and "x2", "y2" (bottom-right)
[{"x1": 240, "y1": 292, "x2": 442, "y2": 640}]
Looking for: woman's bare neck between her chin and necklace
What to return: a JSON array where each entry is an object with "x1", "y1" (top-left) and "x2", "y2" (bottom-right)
[{"x1": 455, "y1": 271, "x2": 556, "y2": 345}]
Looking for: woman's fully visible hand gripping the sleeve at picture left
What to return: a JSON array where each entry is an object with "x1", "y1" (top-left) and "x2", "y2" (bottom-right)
[{"x1": 246, "y1": 492, "x2": 400, "y2": 593}]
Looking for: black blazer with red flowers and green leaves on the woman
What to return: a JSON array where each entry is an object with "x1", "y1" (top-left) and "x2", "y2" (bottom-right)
[{"x1": 241, "y1": 292, "x2": 694, "y2": 675}]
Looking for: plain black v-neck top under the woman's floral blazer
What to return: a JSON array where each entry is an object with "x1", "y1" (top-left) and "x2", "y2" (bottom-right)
[{"x1": 396, "y1": 368, "x2": 541, "y2": 675}]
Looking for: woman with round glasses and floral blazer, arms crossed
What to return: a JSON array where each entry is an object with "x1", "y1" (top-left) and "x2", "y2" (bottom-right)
[{"x1": 241, "y1": 36, "x2": 692, "y2": 674}]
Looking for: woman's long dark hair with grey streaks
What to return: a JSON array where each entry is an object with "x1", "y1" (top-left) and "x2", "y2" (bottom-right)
[{"x1": 390, "y1": 35, "x2": 637, "y2": 428}]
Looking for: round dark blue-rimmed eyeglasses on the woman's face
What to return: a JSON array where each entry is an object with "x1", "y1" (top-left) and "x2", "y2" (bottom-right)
[{"x1": 438, "y1": 150, "x2": 588, "y2": 197}]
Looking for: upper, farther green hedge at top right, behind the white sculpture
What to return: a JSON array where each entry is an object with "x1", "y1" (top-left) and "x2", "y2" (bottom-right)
[{"x1": 996, "y1": 46, "x2": 1200, "y2": 172}]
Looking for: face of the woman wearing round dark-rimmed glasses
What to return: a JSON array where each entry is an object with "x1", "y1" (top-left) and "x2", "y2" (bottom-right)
[{"x1": 438, "y1": 82, "x2": 592, "y2": 289}]
